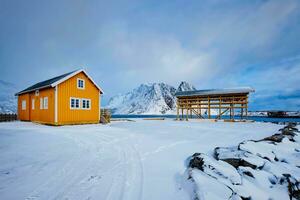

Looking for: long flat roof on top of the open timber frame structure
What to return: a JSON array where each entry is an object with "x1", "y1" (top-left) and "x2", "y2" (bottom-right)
[{"x1": 175, "y1": 87, "x2": 254, "y2": 97}]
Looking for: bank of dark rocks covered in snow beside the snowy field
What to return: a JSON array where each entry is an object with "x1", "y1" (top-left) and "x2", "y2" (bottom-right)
[{"x1": 188, "y1": 124, "x2": 300, "y2": 200}]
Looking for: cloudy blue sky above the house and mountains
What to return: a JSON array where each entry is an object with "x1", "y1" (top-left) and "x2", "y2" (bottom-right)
[{"x1": 0, "y1": 0, "x2": 300, "y2": 110}]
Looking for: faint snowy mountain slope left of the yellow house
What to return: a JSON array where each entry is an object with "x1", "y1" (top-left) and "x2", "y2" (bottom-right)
[{"x1": 0, "y1": 80, "x2": 17, "y2": 113}]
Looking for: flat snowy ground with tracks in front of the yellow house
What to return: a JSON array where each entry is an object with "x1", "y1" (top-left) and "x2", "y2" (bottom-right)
[{"x1": 0, "y1": 119, "x2": 282, "y2": 200}]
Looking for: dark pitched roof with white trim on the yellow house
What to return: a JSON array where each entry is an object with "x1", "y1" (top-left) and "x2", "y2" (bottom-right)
[{"x1": 16, "y1": 69, "x2": 103, "y2": 95}]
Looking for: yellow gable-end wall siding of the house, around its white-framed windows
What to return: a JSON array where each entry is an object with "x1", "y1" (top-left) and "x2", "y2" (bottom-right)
[{"x1": 57, "y1": 72, "x2": 100, "y2": 124}]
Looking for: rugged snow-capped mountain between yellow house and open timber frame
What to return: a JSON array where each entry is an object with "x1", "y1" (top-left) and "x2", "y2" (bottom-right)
[{"x1": 107, "y1": 82, "x2": 195, "y2": 114}]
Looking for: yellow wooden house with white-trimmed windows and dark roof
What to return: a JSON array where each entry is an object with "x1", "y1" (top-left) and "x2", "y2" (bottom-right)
[{"x1": 16, "y1": 70, "x2": 103, "y2": 125}]
